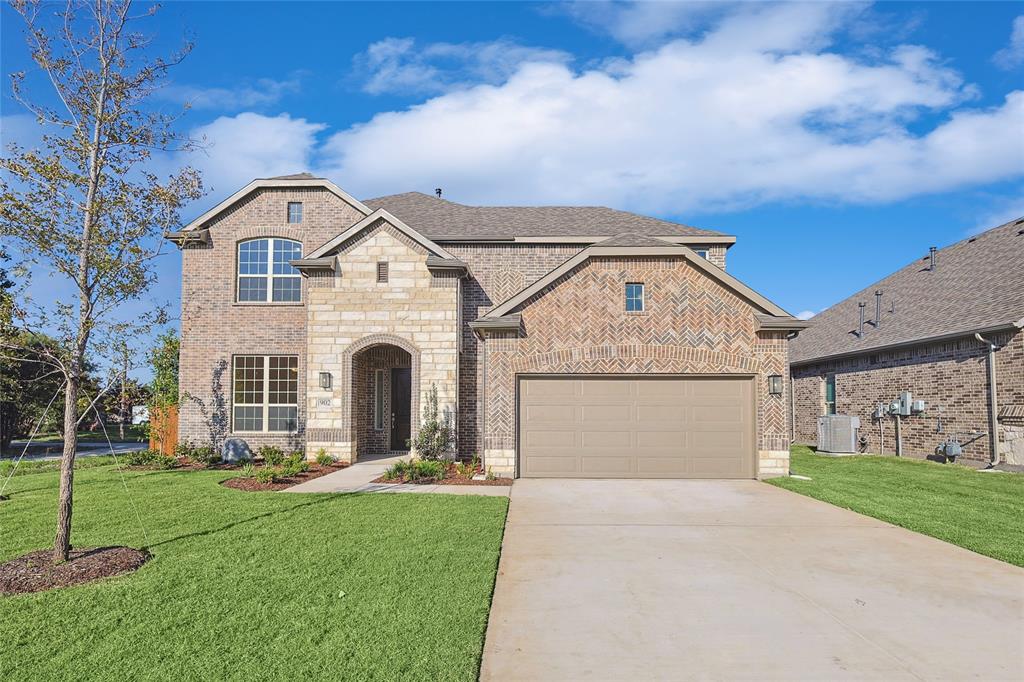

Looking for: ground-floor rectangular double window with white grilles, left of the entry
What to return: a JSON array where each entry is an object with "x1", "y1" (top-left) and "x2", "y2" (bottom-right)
[{"x1": 231, "y1": 355, "x2": 299, "y2": 431}]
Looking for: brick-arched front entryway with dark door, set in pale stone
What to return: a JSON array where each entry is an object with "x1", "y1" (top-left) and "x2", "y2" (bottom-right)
[{"x1": 349, "y1": 337, "x2": 420, "y2": 460}]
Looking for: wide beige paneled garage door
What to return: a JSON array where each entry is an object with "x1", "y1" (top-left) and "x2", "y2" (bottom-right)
[{"x1": 519, "y1": 377, "x2": 755, "y2": 478}]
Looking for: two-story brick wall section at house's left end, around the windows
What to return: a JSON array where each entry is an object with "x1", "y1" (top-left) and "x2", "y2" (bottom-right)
[{"x1": 178, "y1": 187, "x2": 362, "y2": 447}]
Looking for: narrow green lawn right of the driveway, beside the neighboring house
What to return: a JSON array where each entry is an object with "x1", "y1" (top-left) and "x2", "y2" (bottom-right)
[{"x1": 769, "y1": 445, "x2": 1024, "y2": 566}]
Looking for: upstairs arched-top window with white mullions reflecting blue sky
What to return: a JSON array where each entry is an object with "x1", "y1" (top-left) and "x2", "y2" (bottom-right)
[{"x1": 239, "y1": 238, "x2": 302, "y2": 303}]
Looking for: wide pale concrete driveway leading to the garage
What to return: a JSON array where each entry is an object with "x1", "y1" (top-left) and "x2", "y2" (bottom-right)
[{"x1": 481, "y1": 480, "x2": 1024, "y2": 680}]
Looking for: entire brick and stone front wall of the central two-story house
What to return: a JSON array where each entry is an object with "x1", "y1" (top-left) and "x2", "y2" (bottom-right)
[{"x1": 179, "y1": 180, "x2": 770, "y2": 474}]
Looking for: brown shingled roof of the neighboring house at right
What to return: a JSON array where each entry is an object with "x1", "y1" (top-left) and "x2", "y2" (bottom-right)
[{"x1": 790, "y1": 218, "x2": 1024, "y2": 364}]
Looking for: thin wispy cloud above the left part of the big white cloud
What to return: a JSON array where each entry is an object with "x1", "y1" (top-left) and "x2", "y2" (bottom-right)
[{"x1": 353, "y1": 38, "x2": 571, "y2": 95}]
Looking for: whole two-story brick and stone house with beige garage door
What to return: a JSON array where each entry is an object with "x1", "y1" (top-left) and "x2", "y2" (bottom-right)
[{"x1": 169, "y1": 174, "x2": 805, "y2": 477}]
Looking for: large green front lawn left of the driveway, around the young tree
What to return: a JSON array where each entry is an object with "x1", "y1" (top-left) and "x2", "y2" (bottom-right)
[{"x1": 0, "y1": 458, "x2": 508, "y2": 680}]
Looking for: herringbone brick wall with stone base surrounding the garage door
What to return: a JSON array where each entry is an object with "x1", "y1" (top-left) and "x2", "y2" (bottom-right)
[{"x1": 483, "y1": 257, "x2": 790, "y2": 476}]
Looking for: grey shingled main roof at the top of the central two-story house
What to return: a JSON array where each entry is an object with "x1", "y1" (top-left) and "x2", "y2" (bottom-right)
[{"x1": 366, "y1": 191, "x2": 735, "y2": 245}]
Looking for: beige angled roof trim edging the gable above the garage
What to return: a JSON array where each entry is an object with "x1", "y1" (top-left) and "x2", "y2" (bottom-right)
[{"x1": 480, "y1": 240, "x2": 804, "y2": 319}]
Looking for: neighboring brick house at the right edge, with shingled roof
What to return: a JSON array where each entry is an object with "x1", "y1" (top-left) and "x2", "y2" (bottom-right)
[{"x1": 790, "y1": 218, "x2": 1024, "y2": 464}]
